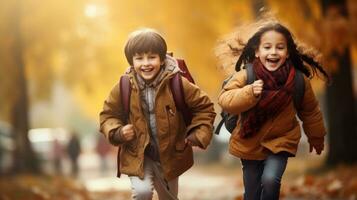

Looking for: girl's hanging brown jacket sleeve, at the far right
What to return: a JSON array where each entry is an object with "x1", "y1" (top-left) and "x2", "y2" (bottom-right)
[{"x1": 298, "y1": 77, "x2": 326, "y2": 145}]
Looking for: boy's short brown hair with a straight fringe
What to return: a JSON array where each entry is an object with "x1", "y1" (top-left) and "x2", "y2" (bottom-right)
[{"x1": 124, "y1": 28, "x2": 167, "y2": 66}]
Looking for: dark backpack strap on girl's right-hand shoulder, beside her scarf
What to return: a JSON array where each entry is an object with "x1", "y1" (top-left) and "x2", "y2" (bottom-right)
[{"x1": 293, "y1": 69, "x2": 305, "y2": 110}]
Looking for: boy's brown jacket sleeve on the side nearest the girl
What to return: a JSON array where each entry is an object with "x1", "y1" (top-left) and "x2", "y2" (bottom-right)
[{"x1": 182, "y1": 77, "x2": 216, "y2": 149}]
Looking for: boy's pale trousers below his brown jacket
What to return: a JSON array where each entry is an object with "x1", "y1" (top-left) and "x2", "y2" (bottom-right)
[{"x1": 129, "y1": 157, "x2": 178, "y2": 200}]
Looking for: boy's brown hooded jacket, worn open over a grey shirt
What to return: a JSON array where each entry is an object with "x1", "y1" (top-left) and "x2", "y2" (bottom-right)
[{"x1": 100, "y1": 57, "x2": 216, "y2": 180}]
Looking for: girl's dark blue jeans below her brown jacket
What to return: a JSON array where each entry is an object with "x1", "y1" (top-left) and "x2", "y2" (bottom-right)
[{"x1": 241, "y1": 153, "x2": 288, "y2": 200}]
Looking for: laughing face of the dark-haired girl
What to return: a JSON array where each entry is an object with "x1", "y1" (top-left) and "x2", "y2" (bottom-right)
[{"x1": 255, "y1": 30, "x2": 289, "y2": 71}]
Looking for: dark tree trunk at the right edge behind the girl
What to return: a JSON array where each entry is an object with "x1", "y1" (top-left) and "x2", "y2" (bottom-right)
[{"x1": 321, "y1": 0, "x2": 357, "y2": 166}]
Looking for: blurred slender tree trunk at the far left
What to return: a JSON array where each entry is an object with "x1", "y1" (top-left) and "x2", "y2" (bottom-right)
[{"x1": 11, "y1": 0, "x2": 39, "y2": 172}]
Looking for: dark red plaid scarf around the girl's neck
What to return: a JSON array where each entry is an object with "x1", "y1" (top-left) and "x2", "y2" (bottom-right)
[{"x1": 239, "y1": 59, "x2": 295, "y2": 138}]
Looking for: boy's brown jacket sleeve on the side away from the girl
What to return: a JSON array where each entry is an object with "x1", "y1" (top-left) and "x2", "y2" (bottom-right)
[{"x1": 99, "y1": 83, "x2": 125, "y2": 145}]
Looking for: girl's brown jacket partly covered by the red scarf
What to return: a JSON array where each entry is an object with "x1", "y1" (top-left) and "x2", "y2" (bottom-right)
[{"x1": 218, "y1": 69, "x2": 326, "y2": 160}]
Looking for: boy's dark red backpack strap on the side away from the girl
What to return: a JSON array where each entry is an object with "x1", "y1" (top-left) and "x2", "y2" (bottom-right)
[{"x1": 119, "y1": 75, "x2": 131, "y2": 123}]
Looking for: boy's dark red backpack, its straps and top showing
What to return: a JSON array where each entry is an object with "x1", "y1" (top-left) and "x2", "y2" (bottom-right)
[{"x1": 119, "y1": 58, "x2": 195, "y2": 126}]
